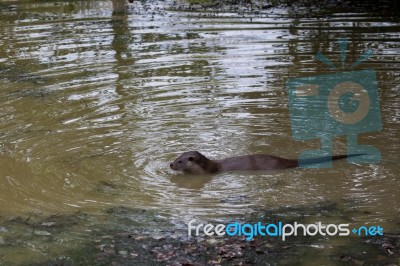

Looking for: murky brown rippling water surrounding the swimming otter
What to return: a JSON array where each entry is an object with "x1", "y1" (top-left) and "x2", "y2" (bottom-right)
[{"x1": 0, "y1": 0, "x2": 400, "y2": 262}]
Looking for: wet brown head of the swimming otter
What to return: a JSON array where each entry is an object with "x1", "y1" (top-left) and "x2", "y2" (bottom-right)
[{"x1": 169, "y1": 151, "x2": 212, "y2": 174}]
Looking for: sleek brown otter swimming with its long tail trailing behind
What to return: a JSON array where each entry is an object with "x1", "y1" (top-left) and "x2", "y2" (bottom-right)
[{"x1": 170, "y1": 151, "x2": 362, "y2": 175}]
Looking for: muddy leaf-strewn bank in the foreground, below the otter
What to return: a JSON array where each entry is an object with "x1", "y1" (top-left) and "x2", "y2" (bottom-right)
[{"x1": 0, "y1": 202, "x2": 400, "y2": 266}]
